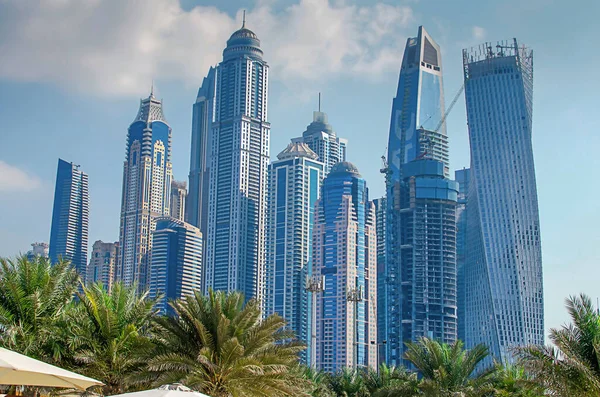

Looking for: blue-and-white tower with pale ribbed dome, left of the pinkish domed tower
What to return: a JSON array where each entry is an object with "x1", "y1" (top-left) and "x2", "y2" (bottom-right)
[{"x1": 264, "y1": 142, "x2": 324, "y2": 362}]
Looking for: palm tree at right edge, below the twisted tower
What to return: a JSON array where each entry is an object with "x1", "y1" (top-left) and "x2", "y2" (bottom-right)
[{"x1": 515, "y1": 294, "x2": 600, "y2": 397}]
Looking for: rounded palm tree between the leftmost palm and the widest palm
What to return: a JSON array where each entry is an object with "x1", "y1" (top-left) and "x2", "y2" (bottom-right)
[{"x1": 68, "y1": 283, "x2": 157, "y2": 395}]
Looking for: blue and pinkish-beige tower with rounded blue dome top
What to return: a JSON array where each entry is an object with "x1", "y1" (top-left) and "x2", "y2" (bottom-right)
[{"x1": 312, "y1": 162, "x2": 377, "y2": 372}]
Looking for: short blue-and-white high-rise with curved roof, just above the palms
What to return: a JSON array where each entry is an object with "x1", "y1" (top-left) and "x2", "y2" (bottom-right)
[{"x1": 149, "y1": 217, "x2": 202, "y2": 313}]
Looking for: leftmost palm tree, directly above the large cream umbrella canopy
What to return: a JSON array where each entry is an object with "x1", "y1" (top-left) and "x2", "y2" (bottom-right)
[{"x1": 0, "y1": 256, "x2": 79, "y2": 361}]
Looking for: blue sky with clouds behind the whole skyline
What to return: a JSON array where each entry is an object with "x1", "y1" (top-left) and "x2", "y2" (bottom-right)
[{"x1": 0, "y1": 0, "x2": 600, "y2": 336}]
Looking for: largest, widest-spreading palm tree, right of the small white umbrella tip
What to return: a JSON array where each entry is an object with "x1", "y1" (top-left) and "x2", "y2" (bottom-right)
[{"x1": 142, "y1": 290, "x2": 310, "y2": 397}]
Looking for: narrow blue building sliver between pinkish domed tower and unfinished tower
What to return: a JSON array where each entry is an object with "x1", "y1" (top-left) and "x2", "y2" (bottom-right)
[{"x1": 373, "y1": 197, "x2": 388, "y2": 365}]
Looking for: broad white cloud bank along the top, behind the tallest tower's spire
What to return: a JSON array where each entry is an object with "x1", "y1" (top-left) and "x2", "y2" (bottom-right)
[{"x1": 0, "y1": 0, "x2": 412, "y2": 96}]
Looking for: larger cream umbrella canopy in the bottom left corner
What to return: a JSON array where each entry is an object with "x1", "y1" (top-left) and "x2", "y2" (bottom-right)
[{"x1": 0, "y1": 347, "x2": 103, "y2": 390}]
